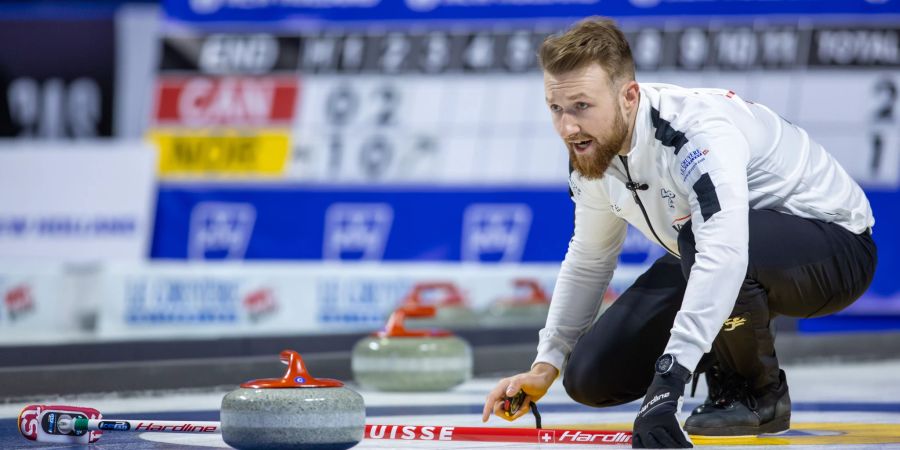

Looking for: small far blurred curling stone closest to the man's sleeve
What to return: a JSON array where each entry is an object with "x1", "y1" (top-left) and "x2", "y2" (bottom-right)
[{"x1": 484, "y1": 278, "x2": 550, "y2": 326}]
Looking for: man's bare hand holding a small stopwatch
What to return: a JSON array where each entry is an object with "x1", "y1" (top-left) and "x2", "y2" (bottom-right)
[{"x1": 481, "y1": 363, "x2": 559, "y2": 422}]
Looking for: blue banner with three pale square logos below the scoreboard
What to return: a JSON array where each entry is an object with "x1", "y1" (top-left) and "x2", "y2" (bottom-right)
[{"x1": 151, "y1": 185, "x2": 576, "y2": 262}]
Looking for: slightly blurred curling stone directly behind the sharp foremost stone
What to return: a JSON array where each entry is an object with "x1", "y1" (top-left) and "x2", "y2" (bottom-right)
[{"x1": 351, "y1": 306, "x2": 472, "y2": 391}]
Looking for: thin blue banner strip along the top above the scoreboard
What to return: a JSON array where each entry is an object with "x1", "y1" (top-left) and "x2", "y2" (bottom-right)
[{"x1": 163, "y1": 0, "x2": 900, "y2": 22}]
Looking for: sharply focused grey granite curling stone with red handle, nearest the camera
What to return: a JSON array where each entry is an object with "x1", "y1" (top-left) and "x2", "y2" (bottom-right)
[{"x1": 221, "y1": 350, "x2": 366, "y2": 450}]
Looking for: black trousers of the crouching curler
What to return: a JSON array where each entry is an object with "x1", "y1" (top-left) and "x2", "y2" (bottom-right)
[{"x1": 563, "y1": 210, "x2": 877, "y2": 407}]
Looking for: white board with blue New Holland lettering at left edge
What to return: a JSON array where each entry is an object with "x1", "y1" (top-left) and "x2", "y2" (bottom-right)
[{"x1": 0, "y1": 141, "x2": 156, "y2": 262}]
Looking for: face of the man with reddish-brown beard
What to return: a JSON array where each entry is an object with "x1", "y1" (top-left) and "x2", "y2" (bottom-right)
[{"x1": 544, "y1": 64, "x2": 628, "y2": 179}]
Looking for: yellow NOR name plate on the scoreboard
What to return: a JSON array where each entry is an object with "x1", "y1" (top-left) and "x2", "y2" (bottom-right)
[{"x1": 148, "y1": 130, "x2": 290, "y2": 177}]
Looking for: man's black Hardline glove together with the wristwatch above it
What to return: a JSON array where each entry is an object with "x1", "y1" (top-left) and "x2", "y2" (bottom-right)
[{"x1": 631, "y1": 354, "x2": 694, "y2": 448}]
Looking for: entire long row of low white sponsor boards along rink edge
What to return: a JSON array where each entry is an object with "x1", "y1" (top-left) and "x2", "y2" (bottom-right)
[{"x1": 0, "y1": 255, "x2": 637, "y2": 343}]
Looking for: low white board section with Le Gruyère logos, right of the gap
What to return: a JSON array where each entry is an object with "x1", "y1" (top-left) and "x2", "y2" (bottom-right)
[{"x1": 97, "y1": 262, "x2": 572, "y2": 339}]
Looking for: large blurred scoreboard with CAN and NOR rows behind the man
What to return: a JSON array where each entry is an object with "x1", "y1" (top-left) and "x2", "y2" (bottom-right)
[{"x1": 153, "y1": 0, "x2": 900, "y2": 188}]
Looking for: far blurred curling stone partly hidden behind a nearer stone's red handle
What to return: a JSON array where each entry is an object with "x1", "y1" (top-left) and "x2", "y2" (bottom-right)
[{"x1": 400, "y1": 282, "x2": 478, "y2": 329}]
